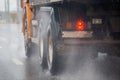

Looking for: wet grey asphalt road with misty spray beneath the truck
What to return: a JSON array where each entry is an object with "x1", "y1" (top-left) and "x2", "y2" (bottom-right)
[{"x1": 0, "y1": 24, "x2": 120, "y2": 80}]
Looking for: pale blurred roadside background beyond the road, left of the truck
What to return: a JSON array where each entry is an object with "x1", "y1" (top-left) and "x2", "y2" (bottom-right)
[{"x1": 0, "y1": 0, "x2": 22, "y2": 23}]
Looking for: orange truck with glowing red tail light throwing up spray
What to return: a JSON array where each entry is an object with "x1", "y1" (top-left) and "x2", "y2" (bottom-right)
[{"x1": 21, "y1": 0, "x2": 120, "y2": 73}]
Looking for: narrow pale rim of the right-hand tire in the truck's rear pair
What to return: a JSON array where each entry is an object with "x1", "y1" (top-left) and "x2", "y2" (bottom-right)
[{"x1": 47, "y1": 37, "x2": 53, "y2": 70}]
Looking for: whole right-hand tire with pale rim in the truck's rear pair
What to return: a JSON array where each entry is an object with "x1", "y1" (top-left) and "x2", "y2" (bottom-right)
[{"x1": 47, "y1": 30, "x2": 58, "y2": 75}]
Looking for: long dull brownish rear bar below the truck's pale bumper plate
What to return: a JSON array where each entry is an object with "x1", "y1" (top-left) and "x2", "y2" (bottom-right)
[{"x1": 57, "y1": 39, "x2": 120, "y2": 55}]
